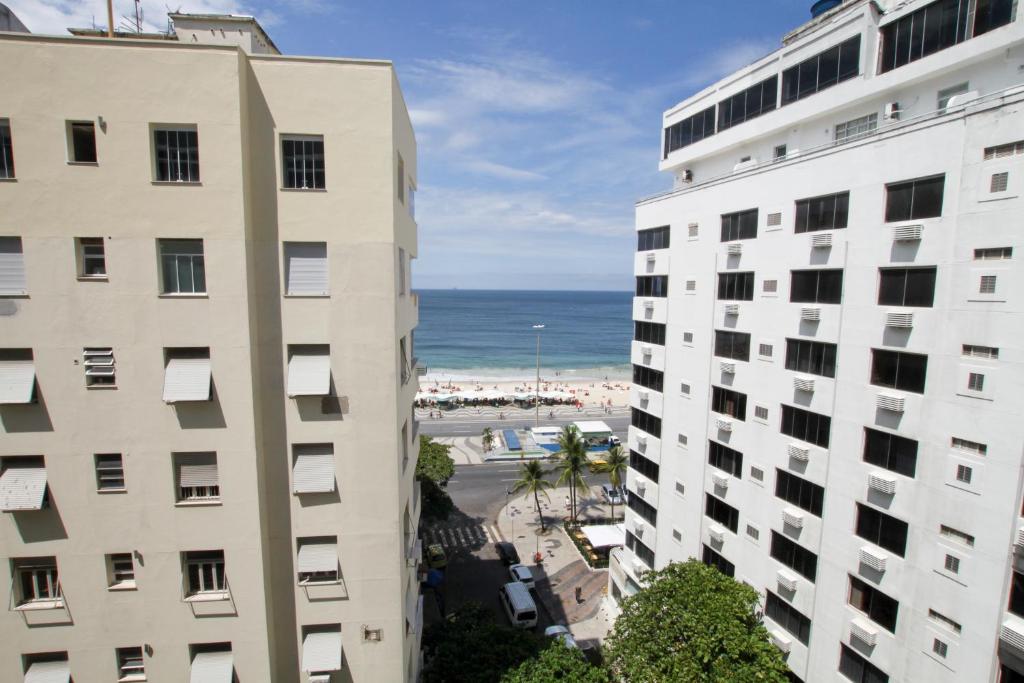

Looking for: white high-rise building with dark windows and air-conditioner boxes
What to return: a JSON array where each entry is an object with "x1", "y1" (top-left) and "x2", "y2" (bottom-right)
[{"x1": 610, "y1": 0, "x2": 1024, "y2": 683}]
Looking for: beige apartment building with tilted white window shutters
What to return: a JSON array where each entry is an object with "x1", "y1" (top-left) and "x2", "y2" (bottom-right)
[{"x1": 0, "y1": 14, "x2": 422, "y2": 683}]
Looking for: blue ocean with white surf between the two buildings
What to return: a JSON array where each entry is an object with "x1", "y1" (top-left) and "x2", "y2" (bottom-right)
[{"x1": 415, "y1": 290, "x2": 633, "y2": 380}]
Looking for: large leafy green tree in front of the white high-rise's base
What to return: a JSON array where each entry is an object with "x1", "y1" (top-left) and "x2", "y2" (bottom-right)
[{"x1": 605, "y1": 560, "x2": 787, "y2": 683}]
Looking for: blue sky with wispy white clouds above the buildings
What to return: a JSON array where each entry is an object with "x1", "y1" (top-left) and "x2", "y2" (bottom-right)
[{"x1": 18, "y1": 0, "x2": 811, "y2": 290}]
